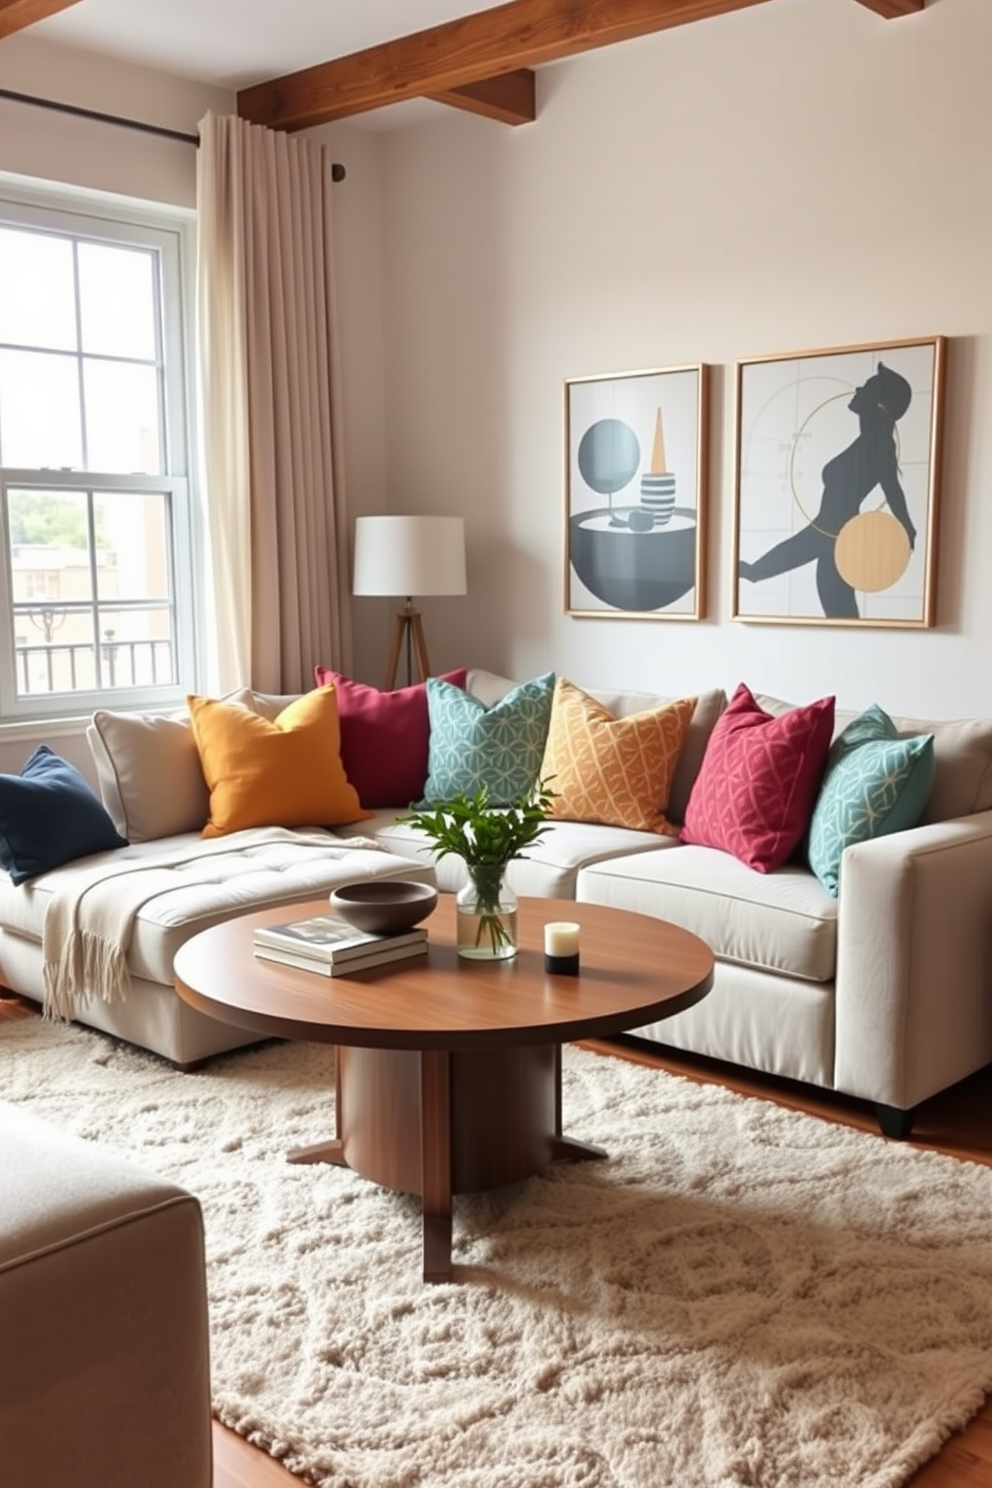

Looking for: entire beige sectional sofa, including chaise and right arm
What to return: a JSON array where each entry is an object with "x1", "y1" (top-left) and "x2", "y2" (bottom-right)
[{"x1": 0, "y1": 671, "x2": 992, "y2": 1135}]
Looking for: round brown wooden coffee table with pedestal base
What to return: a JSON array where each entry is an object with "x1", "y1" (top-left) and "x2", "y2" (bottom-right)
[{"x1": 174, "y1": 894, "x2": 714, "y2": 1281}]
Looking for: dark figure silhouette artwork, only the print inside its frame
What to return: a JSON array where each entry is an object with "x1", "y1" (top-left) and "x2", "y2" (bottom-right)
[{"x1": 735, "y1": 342, "x2": 938, "y2": 623}]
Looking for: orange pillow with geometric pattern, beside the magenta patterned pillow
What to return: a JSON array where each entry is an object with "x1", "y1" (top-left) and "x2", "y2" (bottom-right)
[{"x1": 541, "y1": 677, "x2": 696, "y2": 835}]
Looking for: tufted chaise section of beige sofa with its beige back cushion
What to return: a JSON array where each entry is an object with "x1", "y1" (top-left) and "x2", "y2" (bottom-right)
[{"x1": 0, "y1": 713, "x2": 434, "y2": 1070}]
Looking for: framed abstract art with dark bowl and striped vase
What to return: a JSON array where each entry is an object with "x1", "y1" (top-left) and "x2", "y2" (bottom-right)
[{"x1": 565, "y1": 365, "x2": 708, "y2": 620}]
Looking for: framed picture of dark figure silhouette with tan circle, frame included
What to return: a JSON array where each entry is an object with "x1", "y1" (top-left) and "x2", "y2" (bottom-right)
[{"x1": 732, "y1": 336, "x2": 944, "y2": 628}]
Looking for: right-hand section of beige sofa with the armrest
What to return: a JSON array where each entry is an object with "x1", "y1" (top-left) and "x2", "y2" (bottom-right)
[{"x1": 347, "y1": 671, "x2": 992, "y2": 1135}]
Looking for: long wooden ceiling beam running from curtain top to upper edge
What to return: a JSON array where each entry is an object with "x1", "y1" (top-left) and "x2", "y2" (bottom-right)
[{"x1": 238, "y1": 0, "x2": 773, "y2": 129}]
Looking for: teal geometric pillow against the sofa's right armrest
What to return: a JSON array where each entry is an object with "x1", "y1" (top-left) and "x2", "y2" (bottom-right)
[{"x1": 808, "y1": 704, "x2": 934, "y2": 899}]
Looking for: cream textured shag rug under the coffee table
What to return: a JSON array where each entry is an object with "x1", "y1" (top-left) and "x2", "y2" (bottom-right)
[{"x1": 0, "y1": 1018, "x2": 992, "y2": 1488}]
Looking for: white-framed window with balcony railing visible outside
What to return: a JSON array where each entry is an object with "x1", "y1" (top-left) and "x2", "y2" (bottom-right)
[{"x1": 0, "y1": 189, "x2": 199, "y2": 719}]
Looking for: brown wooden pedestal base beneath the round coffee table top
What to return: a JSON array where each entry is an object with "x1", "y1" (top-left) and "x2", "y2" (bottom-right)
[{"x1": 289, "y1": 1043, "x2": 607, "y2": 1281}]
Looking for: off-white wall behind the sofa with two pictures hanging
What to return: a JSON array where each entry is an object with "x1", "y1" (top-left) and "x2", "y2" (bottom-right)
[{"x1": 364, "y1": 0, "x2": 992, "y2": 717}]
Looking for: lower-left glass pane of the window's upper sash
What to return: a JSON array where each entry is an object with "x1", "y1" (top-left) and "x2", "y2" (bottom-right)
[{"x1": 0, "y1": 351, "x2": 83, "y2": 470}]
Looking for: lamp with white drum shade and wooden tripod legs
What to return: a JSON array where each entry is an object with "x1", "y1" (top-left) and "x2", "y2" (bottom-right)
[{"x1": 351, "y1": 516, "x2": 466, "y2": 692}]
